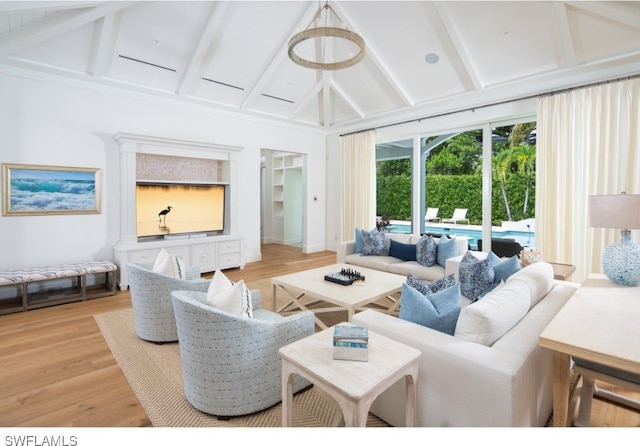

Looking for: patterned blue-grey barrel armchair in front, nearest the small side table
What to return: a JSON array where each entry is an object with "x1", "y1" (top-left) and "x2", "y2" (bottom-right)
[{"x1": 171, "y1": 290, "x2": 315, "y2": 418}]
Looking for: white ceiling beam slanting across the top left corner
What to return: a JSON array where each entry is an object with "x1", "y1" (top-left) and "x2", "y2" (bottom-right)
[{"x1": 0, "y1": 2, "x2": 136, "y2": 56}]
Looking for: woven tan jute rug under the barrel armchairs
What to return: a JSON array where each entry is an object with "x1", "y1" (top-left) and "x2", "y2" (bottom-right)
[{"x1": 95, "y1": 279, "x2": 387, "y2": 427}]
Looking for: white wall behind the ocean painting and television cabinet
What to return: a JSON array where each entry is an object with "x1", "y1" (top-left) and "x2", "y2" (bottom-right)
[{"x1": 0, "y1": 73, "x2": 326, "y2": 269}]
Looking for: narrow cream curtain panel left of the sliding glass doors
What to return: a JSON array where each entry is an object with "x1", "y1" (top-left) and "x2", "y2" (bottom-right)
[{"x1": 340, "y1": 130, "x2": 376, "y2": 241}]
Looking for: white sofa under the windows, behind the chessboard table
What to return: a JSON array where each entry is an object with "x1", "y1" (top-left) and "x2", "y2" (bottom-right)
[{"x1": 336, "y1": 233, "x2": 469, "y2": 282}]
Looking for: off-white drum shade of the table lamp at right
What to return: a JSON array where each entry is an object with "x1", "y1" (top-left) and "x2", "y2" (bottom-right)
[{"x1": 589, "y1": 194, "x2": 640, "y2": 229}]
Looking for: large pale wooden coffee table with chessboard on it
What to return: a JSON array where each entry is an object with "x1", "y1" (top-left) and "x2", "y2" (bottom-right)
[{"x1": 271, "y1": 263, "x2": 406, "y2": 328}]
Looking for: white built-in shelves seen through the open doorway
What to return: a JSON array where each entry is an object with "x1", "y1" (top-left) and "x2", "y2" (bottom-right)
[{"x1": 271, "y1": 153, "x2": 304, "y2": 246}]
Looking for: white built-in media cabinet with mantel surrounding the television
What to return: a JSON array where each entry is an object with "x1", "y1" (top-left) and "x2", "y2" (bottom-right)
[{"x1": 113, "y1": 133, "x2": 245, "y2": 290}]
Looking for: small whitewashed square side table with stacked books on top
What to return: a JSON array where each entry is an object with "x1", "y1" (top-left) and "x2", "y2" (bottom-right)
[{"x1": 280, "y1": 322, "x2": 421, "y2": 427}]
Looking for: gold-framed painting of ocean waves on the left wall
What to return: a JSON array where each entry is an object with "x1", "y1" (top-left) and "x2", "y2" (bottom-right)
[{"x1": 2, "y1": 163, "x2": 102, "y2": 216}]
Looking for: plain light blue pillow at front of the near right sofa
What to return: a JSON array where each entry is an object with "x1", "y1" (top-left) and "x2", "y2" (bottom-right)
[{"x1": 399, "y1": 283, "x2": 460, "y2": 335}]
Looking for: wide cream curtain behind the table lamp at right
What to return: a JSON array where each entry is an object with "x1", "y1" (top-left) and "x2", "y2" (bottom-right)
[{"x1": 536, "y1": 78, "x2": 640, "y2": 283}]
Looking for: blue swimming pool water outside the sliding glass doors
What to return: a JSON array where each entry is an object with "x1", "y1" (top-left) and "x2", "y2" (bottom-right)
[{"x1": 387, "y1": 222, "x2": 536, "y2": 251}]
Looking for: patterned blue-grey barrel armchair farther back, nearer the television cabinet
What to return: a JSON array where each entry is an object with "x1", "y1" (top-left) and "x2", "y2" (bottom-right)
[{"x1": 126, "y1": 263, "x2": 209, "y2": 342}]
